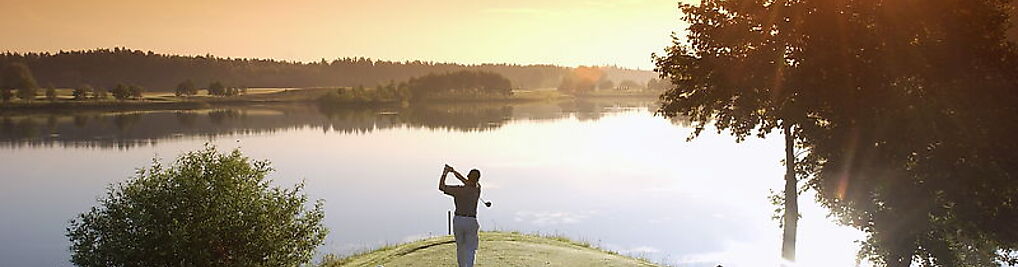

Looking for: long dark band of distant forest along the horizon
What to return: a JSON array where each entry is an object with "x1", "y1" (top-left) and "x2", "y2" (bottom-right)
[{"x1": 0, "y1": 48, "x2": 656, "y2": 92}]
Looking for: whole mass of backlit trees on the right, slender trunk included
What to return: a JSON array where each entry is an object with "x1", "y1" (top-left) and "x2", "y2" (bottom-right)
[{"x1": 655, "y1": 0, "x2": 1018, "y2": 266}]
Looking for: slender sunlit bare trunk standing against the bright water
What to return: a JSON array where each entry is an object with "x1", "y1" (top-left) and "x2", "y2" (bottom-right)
[{"x1": 781, "y1": 124, "x2": 799, "y2": 262}]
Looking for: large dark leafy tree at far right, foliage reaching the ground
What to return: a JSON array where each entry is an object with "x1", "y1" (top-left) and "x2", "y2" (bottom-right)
[{"x1": 799, "y1": 0, "x2": 1018, "y2": 266}]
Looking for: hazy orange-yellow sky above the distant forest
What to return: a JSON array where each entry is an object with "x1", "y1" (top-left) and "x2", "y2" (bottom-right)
[{"x1": 0, "y1": 0, "x2": 680, "y2": 69}]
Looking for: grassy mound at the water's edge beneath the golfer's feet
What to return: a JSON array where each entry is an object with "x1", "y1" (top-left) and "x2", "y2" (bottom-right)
[{"x1": 321, "y1": 231, "x2": 658, "y2": 267}]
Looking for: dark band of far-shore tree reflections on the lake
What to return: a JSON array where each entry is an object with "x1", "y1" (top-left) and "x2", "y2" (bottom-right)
[{"x1": 0, "y1": 99, "x2": 654, "y2": 149}]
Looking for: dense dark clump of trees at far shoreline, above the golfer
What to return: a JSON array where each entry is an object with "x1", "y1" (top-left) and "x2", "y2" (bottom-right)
[{"x1": 406, "y1": 70, "x2": 512, "y2": 101}]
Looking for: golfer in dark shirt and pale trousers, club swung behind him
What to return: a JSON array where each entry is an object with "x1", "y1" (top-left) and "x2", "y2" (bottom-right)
[{"x1": 439, "y1": 165, "x2": 480, "y2": 267}]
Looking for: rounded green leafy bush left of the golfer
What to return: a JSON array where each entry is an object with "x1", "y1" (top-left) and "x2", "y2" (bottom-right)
[{"x1": 67, "y1": 147, "x2": 328, "y2": 266}]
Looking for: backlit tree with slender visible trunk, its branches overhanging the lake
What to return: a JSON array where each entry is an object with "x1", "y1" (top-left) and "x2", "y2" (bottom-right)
[{"x1": 659, "y1": 0, "x2": 819, "y2": 262}]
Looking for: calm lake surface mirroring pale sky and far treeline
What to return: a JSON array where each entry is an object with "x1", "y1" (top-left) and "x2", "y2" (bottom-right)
[{"x1": 0, "y1": 100, "x2": 862, "y2": 267}]
